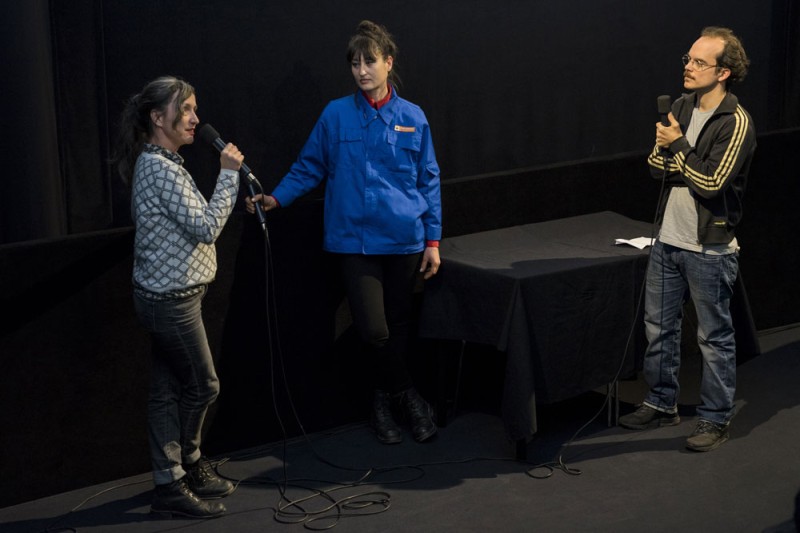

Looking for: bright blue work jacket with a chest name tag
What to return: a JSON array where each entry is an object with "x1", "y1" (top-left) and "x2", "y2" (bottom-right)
[{"x1": 272, "y1": 90, "x2": 442, "y2": 254}]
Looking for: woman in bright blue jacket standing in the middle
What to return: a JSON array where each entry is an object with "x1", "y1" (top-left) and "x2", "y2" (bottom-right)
[{"x1": 248, "y1": 21, "x2": 442, "y2": 444}]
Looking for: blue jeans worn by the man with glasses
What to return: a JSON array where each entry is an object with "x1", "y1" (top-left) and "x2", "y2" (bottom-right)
[{"x1": 644, "y1": 241, "x2": 739, "y2": 424}]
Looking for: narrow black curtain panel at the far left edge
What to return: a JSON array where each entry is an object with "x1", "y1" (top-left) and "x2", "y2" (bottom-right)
[{"x1": 0, "y1": 1, "x2": 69, "y2": 244}]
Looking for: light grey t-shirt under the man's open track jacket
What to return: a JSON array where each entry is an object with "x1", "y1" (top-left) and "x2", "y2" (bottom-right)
[{"x1": 658, "y1": 108, "x2": 739, "y2": 255}]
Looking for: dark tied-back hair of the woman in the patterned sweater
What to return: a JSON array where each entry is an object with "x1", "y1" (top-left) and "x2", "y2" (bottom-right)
[{"x1": 111, "y1": 76, "x2": 194, "y2": 185}]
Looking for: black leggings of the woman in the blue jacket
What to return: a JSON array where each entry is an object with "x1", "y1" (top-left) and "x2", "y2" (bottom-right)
[{"x1": 339, "y1": 252, "x2": 422, "y2": 393}]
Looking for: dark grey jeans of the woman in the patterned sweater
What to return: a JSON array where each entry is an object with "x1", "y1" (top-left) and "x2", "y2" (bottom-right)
[{"x1": 134, "y1": 287, "x2": 219, "y2": 485}]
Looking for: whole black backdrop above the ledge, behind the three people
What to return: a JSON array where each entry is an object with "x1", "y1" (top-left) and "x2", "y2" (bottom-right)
[{"x1": 0, "y1": 0, "x2": 800, "y2": 244}]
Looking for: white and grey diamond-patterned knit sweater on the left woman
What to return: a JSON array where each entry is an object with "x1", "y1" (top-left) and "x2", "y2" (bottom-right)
[{"x1": 131, "y1": 144, "x2": 239, "y2": 293}]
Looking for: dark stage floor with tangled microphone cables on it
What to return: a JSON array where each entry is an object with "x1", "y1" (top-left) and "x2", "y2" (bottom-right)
[{"x1": 0, "y1": 327, "x2": 800, "y2": 533}]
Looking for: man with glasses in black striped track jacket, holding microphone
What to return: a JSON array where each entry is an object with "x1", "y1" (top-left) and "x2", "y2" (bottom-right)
[{"x1": 619, "y1": 27, "x2": 756, "y2": 451}]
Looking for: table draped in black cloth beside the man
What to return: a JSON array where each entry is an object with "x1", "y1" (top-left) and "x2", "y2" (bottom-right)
[{"x1": 420, "y1": 211, "x2": 755, "y2": 443}]
